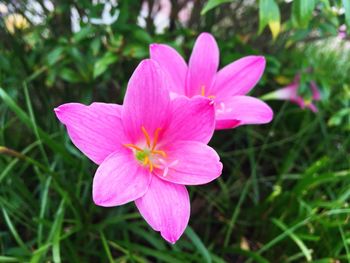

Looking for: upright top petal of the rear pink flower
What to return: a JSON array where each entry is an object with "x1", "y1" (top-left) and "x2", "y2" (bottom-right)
[{"x1": 186, "y1": 33, "x2": 219, "y2": 97}]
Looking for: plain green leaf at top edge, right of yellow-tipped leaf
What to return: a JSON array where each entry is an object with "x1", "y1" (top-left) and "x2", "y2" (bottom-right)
[{"x1": 292, "y1": 0, "x2": 316, "y2": 28}]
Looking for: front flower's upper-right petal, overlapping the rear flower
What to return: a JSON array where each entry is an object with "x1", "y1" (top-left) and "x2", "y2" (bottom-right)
[{"x1": 162, "y1": 96, "x2": 215, "y2": 143}]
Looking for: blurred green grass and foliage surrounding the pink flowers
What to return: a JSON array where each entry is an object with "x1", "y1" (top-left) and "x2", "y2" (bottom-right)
[{"x1": 0, "y1": 0, "x2": 350, "y2": 262}]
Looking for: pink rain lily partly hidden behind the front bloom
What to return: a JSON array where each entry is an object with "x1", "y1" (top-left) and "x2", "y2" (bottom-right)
[{"x1": 150, "y1": 33, "x2": 273, "y2": 129}]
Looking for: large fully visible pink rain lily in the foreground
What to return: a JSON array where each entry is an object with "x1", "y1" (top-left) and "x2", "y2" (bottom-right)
[{"x1": 55, "y1": 60, "x2": 222, "y2": 243}]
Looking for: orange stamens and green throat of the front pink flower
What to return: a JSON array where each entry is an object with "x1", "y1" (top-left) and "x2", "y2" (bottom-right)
[{"x1": 123, "y1": 126, "x2": 167, "y2": 172}]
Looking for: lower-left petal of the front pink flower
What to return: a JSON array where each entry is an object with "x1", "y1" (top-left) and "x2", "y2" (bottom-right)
[{"x1": 92, "y1": 148, "x2": 151, "y2": 207}]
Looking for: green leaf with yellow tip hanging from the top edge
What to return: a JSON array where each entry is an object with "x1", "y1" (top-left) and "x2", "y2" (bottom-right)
[{"x1": 259, "y1": 0, "x2": 281, "y2": 39}]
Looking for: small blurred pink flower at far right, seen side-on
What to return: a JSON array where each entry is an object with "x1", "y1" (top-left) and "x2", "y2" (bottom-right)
[{"x1": 261, "y1": 74, "x2": 321, "y2": 112}]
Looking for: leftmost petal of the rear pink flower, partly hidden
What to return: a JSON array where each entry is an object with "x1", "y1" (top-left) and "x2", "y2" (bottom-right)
[{"x1": 150, "y1": 44, "x2": 187, "y2": 95}]
